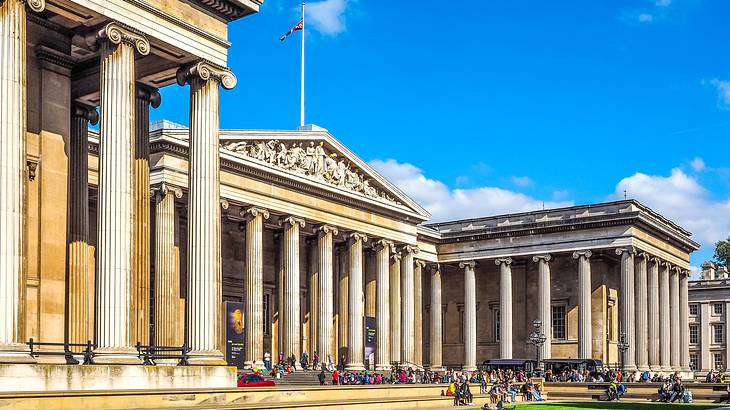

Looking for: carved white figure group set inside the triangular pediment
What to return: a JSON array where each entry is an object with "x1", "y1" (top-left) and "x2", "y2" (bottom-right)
[{"x1": 221, "y1": 140, "x2": 398, "y2": 204}]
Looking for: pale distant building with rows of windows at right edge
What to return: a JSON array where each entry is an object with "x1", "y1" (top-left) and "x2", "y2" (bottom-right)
[{"x1": 688, "y1": 262, "x2": 730, "y2": 377}]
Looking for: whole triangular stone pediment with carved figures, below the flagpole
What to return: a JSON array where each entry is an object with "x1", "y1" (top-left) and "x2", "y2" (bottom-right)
[{"x1": 220, "y1": 129, "x2": 430, "y2": 220}]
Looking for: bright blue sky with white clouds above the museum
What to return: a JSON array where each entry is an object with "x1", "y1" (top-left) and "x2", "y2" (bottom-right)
[{"x1": 152, "y1": 0, "x2": 730, "y2": 272}]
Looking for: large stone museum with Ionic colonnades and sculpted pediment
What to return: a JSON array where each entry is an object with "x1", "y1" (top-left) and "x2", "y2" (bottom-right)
[{"x1": 0, "y1": 0, "x2": 698, "y2": 390}]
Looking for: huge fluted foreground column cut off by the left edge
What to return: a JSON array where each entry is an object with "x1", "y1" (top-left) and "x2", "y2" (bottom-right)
[{"x1": 0, "y1": 0, "x2": 46, "y2": 362}]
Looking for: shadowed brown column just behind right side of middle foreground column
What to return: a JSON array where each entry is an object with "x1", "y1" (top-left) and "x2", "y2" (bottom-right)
[{"x1": 130, "y1": 84, "x2": 161, "y2": 345}]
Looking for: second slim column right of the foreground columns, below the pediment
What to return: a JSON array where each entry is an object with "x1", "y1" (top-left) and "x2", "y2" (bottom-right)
[{"x1": 280, "y1": 216, "x2": 305, "y2": 366}]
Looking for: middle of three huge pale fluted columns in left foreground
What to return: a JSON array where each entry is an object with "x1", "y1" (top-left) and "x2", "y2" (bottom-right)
[{"x1": 87, "y1": 23, "x2": 150, "y2": 363}]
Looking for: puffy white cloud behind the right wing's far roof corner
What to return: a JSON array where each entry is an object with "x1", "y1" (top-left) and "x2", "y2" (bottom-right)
[{"x1": 613, "y1": 168, "x2": 730, "y2": 247}]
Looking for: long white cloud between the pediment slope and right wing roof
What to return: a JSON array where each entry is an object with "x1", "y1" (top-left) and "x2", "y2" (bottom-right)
[{"x1": 370, "y1": 159, "x2": 573, "y2": 222}]
